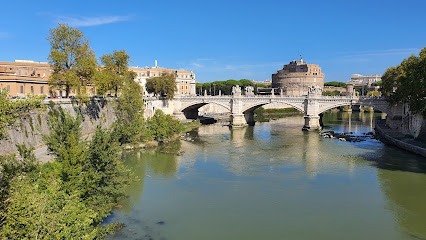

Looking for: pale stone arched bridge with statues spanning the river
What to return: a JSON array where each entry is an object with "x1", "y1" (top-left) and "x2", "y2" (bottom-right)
[{"x1": 145, "y1": 87, "x2": 390, "y2": 130}]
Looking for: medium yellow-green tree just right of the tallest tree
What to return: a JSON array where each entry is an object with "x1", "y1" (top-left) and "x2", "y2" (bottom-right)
[{"x1": 96, "y1": 50, "x2": 136, "y2": 96}]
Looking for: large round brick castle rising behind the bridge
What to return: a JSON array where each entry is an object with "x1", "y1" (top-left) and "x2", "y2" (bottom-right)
[{"x1": 272, "y1": 56, "x2": 324, "y2": 96}]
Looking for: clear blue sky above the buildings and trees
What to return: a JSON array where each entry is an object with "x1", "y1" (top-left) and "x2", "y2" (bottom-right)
[{"x1": 0, "y1": 0, "x2": 426, "y2": 82}]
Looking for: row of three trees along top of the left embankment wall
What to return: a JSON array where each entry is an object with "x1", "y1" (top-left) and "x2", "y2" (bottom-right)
[{"x1": 47, "y1": 24, "x2": 176, "y2": 101}]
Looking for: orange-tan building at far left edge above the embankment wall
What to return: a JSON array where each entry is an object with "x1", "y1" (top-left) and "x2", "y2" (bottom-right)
[{"x1": 0, "y1": 60, "x2": 52, "y2": 97}]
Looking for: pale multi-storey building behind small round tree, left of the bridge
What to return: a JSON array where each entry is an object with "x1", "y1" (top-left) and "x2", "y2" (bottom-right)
[{"x1": 129, "y1": 61, "x2": 196, "y2": 96}]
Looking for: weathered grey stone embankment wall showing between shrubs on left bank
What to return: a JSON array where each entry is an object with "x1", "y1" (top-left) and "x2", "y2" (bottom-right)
[{"x1": 0, "y1": 99, "x2": 115, "y2": 155}]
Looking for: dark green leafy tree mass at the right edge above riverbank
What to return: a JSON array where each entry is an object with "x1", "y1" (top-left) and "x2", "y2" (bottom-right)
[{"x1": 382, "y1": 47, "x2": 426, "y2": 114}]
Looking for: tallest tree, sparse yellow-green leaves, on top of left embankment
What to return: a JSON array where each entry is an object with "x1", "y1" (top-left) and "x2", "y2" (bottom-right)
[{"x1": 47, "y1": 24, "x2": 97, "y2": 97}]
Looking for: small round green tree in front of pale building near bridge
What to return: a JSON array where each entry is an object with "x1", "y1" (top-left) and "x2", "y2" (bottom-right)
[{"x1": 145, "y1": 73, "x2": 177, "y2": 99}]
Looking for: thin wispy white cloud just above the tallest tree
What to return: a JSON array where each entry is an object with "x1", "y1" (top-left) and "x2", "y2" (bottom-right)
[{"x1": 57, "y1": 16, "x2": 130, "y2": 27}]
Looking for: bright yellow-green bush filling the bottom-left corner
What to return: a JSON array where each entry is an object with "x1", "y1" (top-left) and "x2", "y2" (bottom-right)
[{"x1": 0, "y1": 174, "x2": 106, "y2": 239}]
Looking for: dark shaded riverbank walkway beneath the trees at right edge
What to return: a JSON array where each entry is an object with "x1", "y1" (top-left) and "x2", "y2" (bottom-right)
[{"x1": 375, "y1": 120, "x2": 426, "y2": 157}]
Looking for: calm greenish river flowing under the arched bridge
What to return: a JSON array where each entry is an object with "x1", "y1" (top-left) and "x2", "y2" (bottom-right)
[{"x1": 105, "y1": 112, "x2": 426, "y2": 240}]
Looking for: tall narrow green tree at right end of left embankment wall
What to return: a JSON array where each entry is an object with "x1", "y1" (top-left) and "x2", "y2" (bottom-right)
[{"x1": 113, "y1": 80, "x2": 144, "y2": 144}]
